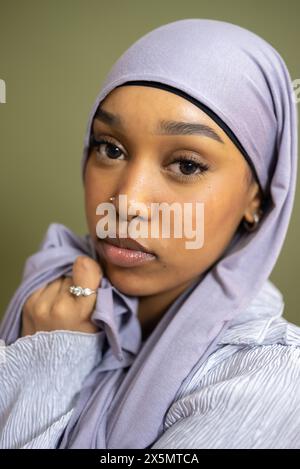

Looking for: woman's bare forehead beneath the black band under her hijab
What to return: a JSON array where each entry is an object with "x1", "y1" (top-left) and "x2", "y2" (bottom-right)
[{"x1": 94, "y1": 85, "x2": 226, "y2": 144}]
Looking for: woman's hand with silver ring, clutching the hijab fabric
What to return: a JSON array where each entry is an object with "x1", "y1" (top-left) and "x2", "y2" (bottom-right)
[{"x1": 21, "y1": 256, "x2": 103, "y2": 337}]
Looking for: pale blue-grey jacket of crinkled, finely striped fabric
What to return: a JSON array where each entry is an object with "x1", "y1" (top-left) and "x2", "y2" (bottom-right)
[{"x1": 0, "y1": 280, "x2": 300, "y2": 449}]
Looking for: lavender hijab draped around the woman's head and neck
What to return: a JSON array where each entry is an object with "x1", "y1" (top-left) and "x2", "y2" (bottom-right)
[{"x1": 0, "y1": 19, "x2": 297, "y2": 449}]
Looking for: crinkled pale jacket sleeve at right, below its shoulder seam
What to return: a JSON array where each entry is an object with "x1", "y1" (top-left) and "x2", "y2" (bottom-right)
[{"x1": 154, "y1": 343, "x2": 300, "y2": 449}]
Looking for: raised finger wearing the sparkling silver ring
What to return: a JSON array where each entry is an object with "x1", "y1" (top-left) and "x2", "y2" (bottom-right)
[{"x1": 73, "y1": 256, "x2": 103, "y2": 313}]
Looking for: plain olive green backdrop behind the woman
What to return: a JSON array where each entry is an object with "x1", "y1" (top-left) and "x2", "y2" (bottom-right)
[{"x1": 0, "y1": 0, "x2": 300, "y2": 324}]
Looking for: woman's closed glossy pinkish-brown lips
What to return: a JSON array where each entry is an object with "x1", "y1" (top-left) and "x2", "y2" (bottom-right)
[{"x1": 96, "y1": 238, "x2": 156, "y2": 267}]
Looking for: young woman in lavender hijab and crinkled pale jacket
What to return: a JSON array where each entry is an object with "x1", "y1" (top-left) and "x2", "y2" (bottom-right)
[{"x1": 0, "y1": 19, "x2": 300, "y2": 448}]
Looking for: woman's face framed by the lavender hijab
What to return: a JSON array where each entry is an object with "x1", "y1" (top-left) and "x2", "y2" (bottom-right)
[{"x1": 85, "y1": 86, "x2": 259, "y2": 296}]
